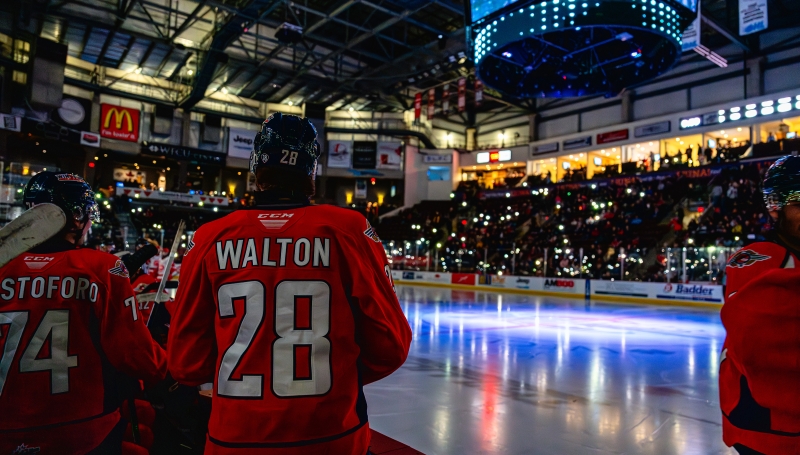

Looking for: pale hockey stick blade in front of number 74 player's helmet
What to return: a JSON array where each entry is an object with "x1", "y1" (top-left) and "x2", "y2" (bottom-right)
[{"x1": 0, "y1": 204, "x2": 67, "y2": 267}]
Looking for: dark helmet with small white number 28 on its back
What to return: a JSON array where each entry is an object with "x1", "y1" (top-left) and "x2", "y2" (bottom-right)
[{"x1": 250, "y1": 112, "x2": 320, "y2": 177}]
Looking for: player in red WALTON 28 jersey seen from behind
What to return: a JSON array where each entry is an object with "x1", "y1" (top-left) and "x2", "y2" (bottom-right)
[{"x1": 167, "y1": 113, "x2": 411, "y2": 455}]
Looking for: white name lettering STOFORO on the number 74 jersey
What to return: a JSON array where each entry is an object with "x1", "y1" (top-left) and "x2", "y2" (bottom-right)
[{"x1": 0, "y1": 276, "x2": 99, "y2": 302}]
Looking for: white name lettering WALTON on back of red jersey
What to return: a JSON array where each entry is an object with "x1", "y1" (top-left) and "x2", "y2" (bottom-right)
[{"x1": 217, "y1": 237, "x2": 331, "y2": 270}]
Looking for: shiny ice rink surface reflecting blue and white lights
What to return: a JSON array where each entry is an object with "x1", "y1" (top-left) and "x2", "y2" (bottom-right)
[{"x1": 365, "y1": 286, "x2": 736, "y2": 455}]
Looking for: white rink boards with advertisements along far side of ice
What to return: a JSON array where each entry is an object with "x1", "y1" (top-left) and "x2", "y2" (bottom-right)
[{"x1": 392, "y1": 270, "x2": 724, "y2": 306}]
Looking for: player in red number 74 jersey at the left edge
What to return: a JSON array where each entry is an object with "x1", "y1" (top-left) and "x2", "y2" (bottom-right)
[{"x1": 0, "y1": 172, "x2": 166, "y2": 454}]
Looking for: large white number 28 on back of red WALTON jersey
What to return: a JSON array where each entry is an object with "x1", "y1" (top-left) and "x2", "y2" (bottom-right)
[{"x1": 217, "y1": 281, "x2": 331, "y2": 398}]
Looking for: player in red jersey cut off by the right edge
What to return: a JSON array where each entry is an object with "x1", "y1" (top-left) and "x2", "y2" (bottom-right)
[{"x1": 719, "y1": 156, "x2": 800, "y2": 455}]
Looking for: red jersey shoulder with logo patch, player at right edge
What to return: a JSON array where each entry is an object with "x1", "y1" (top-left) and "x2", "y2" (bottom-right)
[{"x1": 725, "y1": 242, "x2": 800, "y2": 288}]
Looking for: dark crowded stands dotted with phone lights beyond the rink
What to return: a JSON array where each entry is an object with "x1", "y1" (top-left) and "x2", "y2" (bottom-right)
[{"x1": 378, "y1": 161, "x2": 770, "y2": 280}]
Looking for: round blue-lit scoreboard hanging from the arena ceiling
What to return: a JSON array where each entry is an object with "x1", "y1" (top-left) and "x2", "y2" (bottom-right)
[{"x1": 469, "y1": 0, "x2": 695, "y2": 99}]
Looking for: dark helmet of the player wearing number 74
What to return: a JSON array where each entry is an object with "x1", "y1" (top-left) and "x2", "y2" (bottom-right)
[{"x1": 22, "y1": 171, "x2": 100, "y2": 222}]
